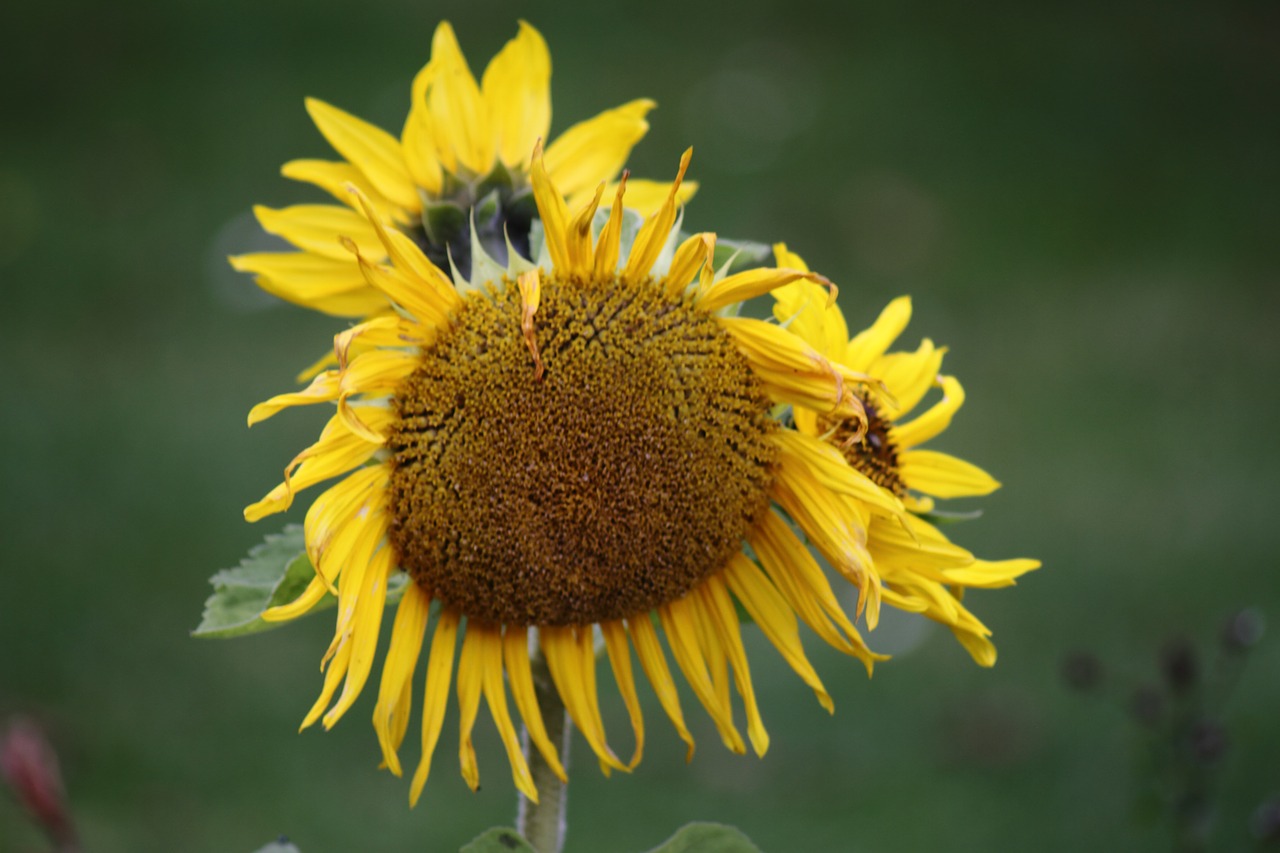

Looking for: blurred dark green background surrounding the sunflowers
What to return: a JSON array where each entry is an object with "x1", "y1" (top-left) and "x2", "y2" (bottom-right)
[{"x1": 0, "y1": 0, "x2": 1280, "y2": 853}]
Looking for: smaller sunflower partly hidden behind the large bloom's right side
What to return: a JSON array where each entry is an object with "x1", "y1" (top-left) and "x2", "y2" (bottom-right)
[{"x1": 773, "y1": 243, "x2": 1041, "y2": 666}]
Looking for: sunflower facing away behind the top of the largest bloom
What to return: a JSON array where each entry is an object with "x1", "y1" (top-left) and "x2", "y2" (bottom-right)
[{"x1": 232, "y1": 22, "x2": 695, "y2": 350}]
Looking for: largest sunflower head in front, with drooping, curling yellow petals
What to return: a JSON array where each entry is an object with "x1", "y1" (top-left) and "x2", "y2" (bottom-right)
[{"x1": 246, "y1": 146, "x2": 904, "y2": 800}]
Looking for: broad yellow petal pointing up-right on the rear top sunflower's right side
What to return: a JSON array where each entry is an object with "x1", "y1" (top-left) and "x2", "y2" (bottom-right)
[{"x1": 547, "y1": 99, "x2": 657, "y2": 196}]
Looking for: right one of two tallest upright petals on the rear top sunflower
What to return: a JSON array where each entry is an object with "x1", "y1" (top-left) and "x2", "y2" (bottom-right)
[{"x1": 480, "y1": 20, "x2": 552, "y2": 167}]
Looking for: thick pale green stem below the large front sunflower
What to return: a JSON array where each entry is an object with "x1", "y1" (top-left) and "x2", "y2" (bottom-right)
[{"x1": 516, "y1": 649, "x2": 573, "y2": 853}]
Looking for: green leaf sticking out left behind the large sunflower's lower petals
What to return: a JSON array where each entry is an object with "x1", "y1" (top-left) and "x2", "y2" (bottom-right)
[{"x1": 191, "y1": 524, "x2": 406, "y2": 639}]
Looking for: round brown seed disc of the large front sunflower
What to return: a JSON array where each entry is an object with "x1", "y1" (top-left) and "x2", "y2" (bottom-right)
[{"x1": 388, "y1": 272, "x2": 776, "y2": 625}]
